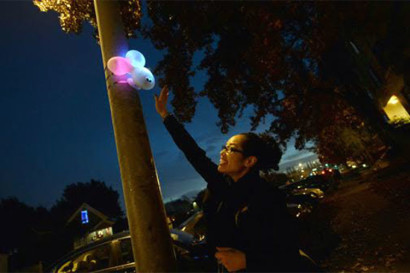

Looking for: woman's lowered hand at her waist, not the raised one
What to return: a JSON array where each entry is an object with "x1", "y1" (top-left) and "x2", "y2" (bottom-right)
[{"x1": 215, "y1": 247, "x2": 246, "y2": 272}]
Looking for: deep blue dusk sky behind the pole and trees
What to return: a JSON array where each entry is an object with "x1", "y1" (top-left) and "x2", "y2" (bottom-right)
[{"x1": 0, "y1": 1, "x2": 313, "y2": 207}]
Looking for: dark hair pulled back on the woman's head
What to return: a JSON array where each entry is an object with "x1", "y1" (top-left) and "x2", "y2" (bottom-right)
[{"x1": 239, "y1": 133, "x2": 282, "y2": 171}]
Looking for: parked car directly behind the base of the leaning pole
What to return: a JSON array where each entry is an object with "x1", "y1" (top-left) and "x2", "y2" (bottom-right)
[{"x1": 47, "y1": 229, "x2": 210, "y2": 273}]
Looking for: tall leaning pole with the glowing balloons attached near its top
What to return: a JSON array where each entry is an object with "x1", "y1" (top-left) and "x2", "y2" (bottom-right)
[{"x1": 94, "y1": 0, "x2": 176, "y2": 272}]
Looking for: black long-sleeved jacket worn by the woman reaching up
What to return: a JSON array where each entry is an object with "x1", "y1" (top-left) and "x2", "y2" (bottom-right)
[{"x1": 164, "y1": 115, "x2": 300, "y2": 272}]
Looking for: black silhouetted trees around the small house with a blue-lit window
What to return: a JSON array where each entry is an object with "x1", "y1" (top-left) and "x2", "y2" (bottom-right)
[{"x1": 0, "y1": 179, "x2": 126, "y2": 270}]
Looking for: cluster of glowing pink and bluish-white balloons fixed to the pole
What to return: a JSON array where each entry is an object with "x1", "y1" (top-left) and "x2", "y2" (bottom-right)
[{"x1": 107, "y1": 50, "x2": 155, "y2": 90}]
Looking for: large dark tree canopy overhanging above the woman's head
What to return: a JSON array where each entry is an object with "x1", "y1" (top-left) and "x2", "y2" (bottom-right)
[{"x1": 143, "y1": 1, "x2": 410, "y2": 161}]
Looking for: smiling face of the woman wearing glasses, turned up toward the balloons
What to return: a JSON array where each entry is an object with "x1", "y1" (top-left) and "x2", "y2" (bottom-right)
[{"x1": 218, "y1": 135, "x2": 250, "y2": 181}]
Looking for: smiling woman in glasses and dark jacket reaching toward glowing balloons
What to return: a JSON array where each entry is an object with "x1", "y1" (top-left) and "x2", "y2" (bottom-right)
[{"x1": 155, "y1": 87, "x2": 300, "y2": 272}]
